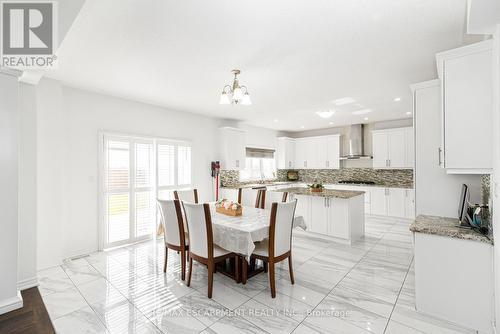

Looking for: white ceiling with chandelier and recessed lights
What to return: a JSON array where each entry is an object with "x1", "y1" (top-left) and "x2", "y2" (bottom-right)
[{"x1": 47, "y1": 0, "x2": 476, "y2": 131}]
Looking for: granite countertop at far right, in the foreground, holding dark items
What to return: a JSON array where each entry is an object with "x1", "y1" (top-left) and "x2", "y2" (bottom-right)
[{"x1": 410, "y1": 215, "x2": 493, "y2": 245}]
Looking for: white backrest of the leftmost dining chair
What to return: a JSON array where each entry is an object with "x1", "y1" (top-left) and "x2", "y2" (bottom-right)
[{"x1": 157, "y1": 199, "x2": 186, "y2": 247}]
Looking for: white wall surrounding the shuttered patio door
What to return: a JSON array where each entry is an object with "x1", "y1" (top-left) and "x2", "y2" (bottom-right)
[{"x1": 37, "y1": 79, "x2": 219, "y2": 268}]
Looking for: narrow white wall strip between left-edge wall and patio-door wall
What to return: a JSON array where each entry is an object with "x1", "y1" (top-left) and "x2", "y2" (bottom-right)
[{"x1": 18, "y1": 83, "x2": 37, "y2": 290}]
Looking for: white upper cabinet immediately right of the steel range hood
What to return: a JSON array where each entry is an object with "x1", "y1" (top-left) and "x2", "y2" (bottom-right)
[{"x1": 372, "y1": 127, "x2": 414, "y2": 169}]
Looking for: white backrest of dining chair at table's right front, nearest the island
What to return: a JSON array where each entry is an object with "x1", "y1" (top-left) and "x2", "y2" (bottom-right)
[{"x1": 269, "y1": 200, "x2": 297, "y2": 257}]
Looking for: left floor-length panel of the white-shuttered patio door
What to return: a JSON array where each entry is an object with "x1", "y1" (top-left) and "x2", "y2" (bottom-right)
[{"x1": 103, "y1": 136, "x2": 156, "y2": 248}]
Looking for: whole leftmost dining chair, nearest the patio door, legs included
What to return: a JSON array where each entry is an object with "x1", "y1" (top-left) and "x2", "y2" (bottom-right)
[{"x1": 157, "y1": 200, "x2": 189, "y2": 280}]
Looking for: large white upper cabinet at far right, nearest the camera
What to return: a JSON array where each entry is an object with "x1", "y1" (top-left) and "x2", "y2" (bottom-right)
[{"x1": 436, "y1": 40, "x2": 493, "y2": 174}]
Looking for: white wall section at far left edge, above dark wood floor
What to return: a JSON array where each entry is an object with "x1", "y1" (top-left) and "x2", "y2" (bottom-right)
[{"x1": 0, "y1": 73, "x2": 22, "y2": 314}]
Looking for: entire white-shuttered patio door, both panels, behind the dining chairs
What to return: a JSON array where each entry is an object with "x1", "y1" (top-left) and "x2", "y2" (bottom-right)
[{"x1": 102, "y1": 135, "x2": 191, "y2": 248}]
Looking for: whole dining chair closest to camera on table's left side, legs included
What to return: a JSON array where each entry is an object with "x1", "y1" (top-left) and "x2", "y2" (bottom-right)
[{"x1": 182, "y1": 202, "x2": 237, "y2": 298}]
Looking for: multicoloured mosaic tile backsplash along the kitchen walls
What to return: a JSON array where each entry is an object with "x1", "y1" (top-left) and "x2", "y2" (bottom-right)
[{"x1": 220, "y1": 168, "x2": 413, "y2": 188}]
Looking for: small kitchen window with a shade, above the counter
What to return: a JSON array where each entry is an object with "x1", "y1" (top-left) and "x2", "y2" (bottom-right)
[{"x1": 240, "y1": 148, "x2": 276, "y2": 181}]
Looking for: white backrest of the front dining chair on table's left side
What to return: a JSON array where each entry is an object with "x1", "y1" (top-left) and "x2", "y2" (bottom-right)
[{"x1": 182, "y1": 202, "x2": 214, "y2": 258}]
